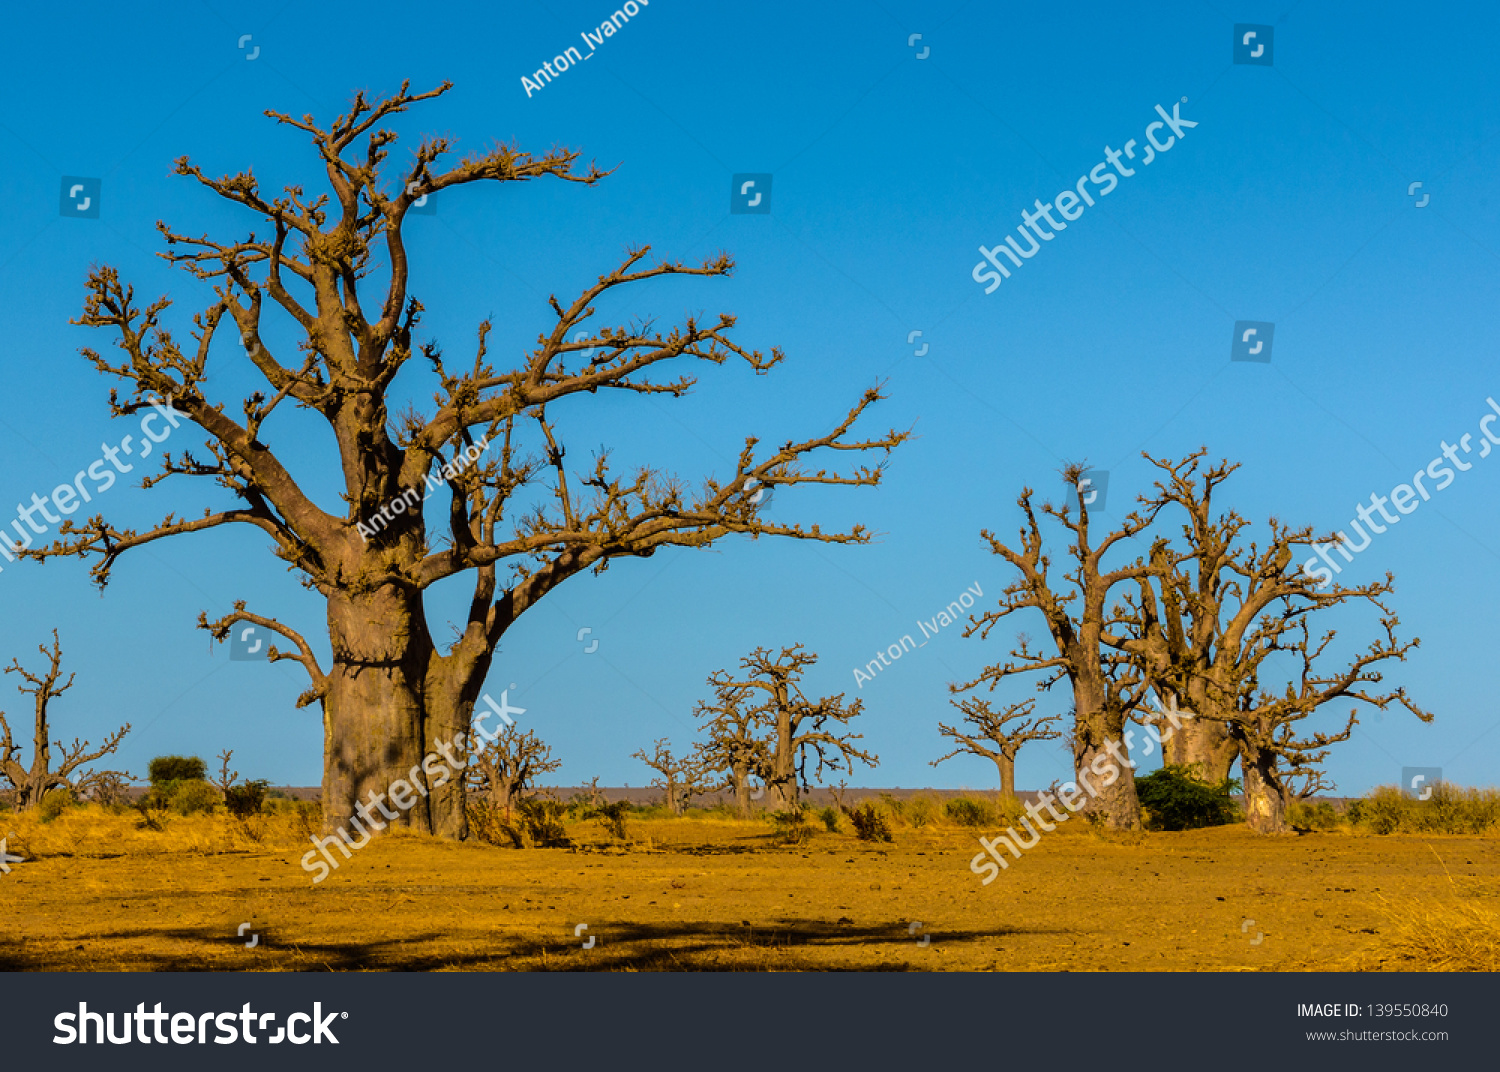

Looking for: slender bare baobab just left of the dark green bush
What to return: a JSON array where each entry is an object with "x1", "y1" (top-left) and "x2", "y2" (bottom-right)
[{"x1": 954, "y1": 465, "x2": 1160, "y2": 829}]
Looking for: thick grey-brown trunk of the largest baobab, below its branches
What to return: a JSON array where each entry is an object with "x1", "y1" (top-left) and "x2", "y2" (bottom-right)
[{"x1": 323, "y1": 586, "x2": 477, "y2": 840}]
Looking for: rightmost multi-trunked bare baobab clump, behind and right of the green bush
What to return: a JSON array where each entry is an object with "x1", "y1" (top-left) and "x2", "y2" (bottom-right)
[{"x1": 1110, "y1": 450, "x2": 1431, "y2": 834}]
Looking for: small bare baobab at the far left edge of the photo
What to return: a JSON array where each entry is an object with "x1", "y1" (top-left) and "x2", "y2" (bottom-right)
[{"x1": 0, "y1": 630, "x2": 131, "y2": 811}]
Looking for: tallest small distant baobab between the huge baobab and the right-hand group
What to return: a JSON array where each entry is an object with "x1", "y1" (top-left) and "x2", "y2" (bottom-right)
[{"x1": 710, "y1": 645, "x2": 881, "y2": 811}]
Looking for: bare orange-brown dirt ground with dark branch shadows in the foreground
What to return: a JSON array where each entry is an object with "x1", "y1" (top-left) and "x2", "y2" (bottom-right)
[{"x1": 0, "y1": 819, "x2": 1500, "y2": 972}]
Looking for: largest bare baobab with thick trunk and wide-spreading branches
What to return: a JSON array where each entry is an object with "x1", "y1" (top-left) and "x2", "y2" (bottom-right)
[{"x1": 27, "y1": 84, "x2": 905, "y2": 837}]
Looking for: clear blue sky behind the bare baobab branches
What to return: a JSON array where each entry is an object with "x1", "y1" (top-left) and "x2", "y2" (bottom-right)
[{"x1": 0, "y1": 0, "x2": 1500, "y2": 792}]
